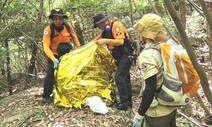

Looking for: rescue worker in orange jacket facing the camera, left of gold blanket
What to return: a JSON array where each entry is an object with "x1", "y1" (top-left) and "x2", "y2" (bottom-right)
[{"x1": 43, "y1": 8, "x2": 80, "y2": 103}]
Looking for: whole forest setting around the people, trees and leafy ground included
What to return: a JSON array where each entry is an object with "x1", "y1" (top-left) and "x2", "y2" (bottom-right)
[{"x1": 0, "y1": 0, "x2": 212, "y2": 127}]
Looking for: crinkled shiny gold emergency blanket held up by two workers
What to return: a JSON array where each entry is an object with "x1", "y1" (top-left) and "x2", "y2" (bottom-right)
[{"x1": 54, "y1": 43, "x2": 116, "y2": 108}]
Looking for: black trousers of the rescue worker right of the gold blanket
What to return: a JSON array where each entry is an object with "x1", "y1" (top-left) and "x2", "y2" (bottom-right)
[{"x1": 115, "y1": 56, "x2": 132, "y2": 102}]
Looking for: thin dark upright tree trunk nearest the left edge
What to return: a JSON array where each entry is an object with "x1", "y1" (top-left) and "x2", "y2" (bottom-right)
[{"x1": 5, "y1": 39, "x2": 13, "y2": 95}]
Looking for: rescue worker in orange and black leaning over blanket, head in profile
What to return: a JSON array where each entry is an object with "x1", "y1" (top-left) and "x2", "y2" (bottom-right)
[{"x1": 92, "y1": 13, "x2": 132, "y2": 110}]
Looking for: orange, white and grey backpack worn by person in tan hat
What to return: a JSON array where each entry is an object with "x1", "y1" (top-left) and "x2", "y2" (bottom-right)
[{"x1": 148, "y1": 41, "x2": 200, "y2": 106}]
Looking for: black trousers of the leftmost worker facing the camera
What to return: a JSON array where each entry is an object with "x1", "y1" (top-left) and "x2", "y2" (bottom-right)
[{"x1": 43, "y1": 56, "x2": 59, "y2": 97}]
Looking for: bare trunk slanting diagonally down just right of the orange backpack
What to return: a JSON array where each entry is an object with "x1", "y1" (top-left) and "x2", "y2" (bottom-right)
[{"x1": 164, "y1": 0, "x2": 212, "y2": 104}]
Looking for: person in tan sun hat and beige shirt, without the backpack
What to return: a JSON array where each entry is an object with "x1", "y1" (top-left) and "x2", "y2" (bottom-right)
[{"x1": 133, "y1": 14, "x2": 177, "y2": 127}]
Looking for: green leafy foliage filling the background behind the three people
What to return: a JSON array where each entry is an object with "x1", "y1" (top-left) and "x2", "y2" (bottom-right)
[{"x1": 0, "y1": 0, "x2": 207, "y2": 79}]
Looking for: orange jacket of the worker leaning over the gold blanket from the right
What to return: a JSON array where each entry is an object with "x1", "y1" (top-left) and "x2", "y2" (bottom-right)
[{"x1": 92, "y1": 20, "x2": 129, "y2": 49}]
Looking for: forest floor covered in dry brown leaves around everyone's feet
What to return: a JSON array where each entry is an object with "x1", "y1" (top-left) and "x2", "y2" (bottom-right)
[{"x1": 0, "y1": 67, "x2": 212, "y2": 127}]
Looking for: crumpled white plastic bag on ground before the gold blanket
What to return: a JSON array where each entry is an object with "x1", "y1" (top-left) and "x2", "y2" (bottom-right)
[{"x1": 86, "y1": 96, "x2": 108, "y2": 114}]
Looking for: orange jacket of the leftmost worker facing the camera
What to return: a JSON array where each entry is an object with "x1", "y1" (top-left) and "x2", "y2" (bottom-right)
[{"x1": 43, "y1": 24, "x2": 80, "y2": 61}]
